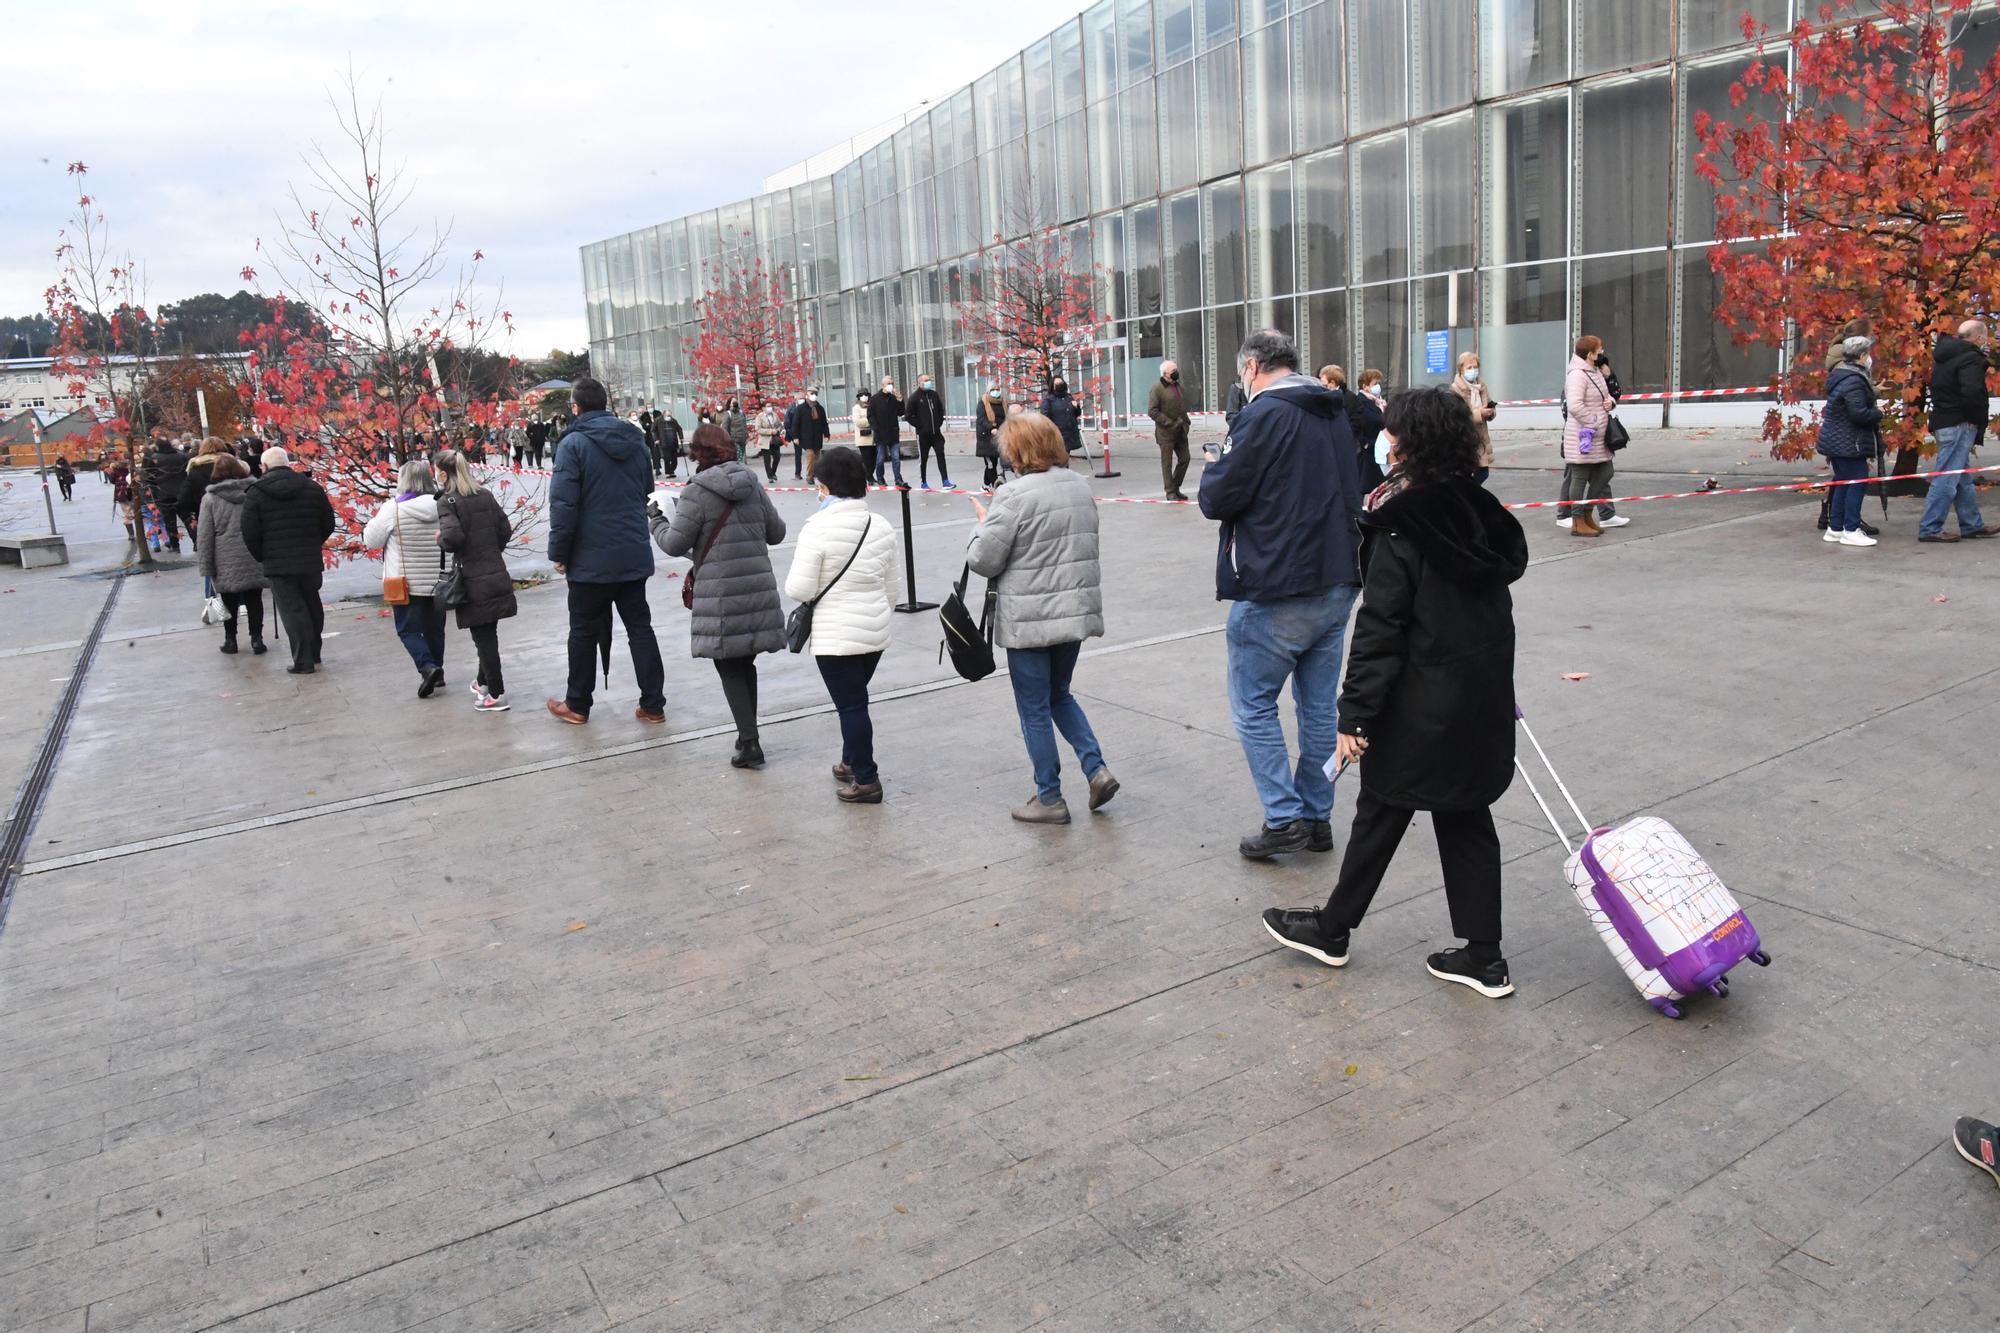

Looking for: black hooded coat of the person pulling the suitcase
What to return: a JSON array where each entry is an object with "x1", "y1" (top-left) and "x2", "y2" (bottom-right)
[{"x1": 1340, "y1": 476, "x2": 1528, "y2": 811}]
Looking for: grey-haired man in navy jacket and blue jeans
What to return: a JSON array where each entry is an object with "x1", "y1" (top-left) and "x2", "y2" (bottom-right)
[{"x1": 1200, "y1": 330, "x2": 1360, "y2": 861}]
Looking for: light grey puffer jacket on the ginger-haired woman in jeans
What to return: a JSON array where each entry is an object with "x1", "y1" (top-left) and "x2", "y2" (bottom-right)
[{"x1": 966, "y1": 468, "x2": 1104, "y2": 648}]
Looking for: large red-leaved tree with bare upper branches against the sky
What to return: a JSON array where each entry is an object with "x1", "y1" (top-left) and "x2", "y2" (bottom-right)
[{"x1": 242, "y1": 72, "x2": 540, "y2": 564}]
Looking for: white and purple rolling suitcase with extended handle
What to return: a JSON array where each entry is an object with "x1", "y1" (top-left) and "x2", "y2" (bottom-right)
[{"x1": 1514, "y1": 709, "x2": 1770, "y2": 1019}]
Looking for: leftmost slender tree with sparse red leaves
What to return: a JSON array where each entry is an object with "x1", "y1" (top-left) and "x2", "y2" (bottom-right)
[{"x1": 42, "y1": 162, "x2": 152, "y2": 566}]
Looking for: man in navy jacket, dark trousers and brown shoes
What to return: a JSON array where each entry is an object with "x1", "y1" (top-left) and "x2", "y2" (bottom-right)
[{"x1": 548, "y1": 376, "x2": 666, "y2": 727}]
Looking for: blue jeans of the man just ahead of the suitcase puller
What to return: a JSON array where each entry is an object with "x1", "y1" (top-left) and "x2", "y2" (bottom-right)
[{"x1": 1228, "y1": 584, "x2": 1360, "y2": 829}]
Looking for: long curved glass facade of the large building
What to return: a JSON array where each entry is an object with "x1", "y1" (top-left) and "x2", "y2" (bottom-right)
[{"x1": 582, "y1": 0, "x2": 2000, "y2": 416}]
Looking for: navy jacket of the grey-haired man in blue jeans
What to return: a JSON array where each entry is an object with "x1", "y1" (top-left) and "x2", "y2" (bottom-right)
[{"x1": 1198, "y1": 374, "x2": 1362, "y2": 602}]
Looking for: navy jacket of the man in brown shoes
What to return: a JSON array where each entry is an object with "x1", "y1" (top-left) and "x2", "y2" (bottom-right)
[{"x1": 548, "y1": 412, "x2": 652, "y2": 582}]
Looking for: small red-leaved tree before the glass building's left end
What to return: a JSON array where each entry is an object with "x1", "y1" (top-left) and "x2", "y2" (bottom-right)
[{"x1": 688, "y1": 236, "x2": 818, "y2": 416}]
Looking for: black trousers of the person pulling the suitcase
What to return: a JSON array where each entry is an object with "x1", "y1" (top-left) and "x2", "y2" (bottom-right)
[{"x1": 1320, "y1": 789, "x2": 1500, "y2": 943}]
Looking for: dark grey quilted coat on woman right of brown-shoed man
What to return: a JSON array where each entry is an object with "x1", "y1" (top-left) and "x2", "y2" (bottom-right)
[{"x1": 652, "y1": 462, "x2": 784, "y2": 658}]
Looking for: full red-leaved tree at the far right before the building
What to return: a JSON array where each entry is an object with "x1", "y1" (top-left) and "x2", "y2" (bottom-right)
[{"x1": 1694, "y1": 0, "x2": 2000, "y2": 460}]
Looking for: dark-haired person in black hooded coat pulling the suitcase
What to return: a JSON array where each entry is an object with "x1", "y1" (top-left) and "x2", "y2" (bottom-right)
[{"x1": 1264, "y1": 386, "x2": 1528, "y2": 997}]
